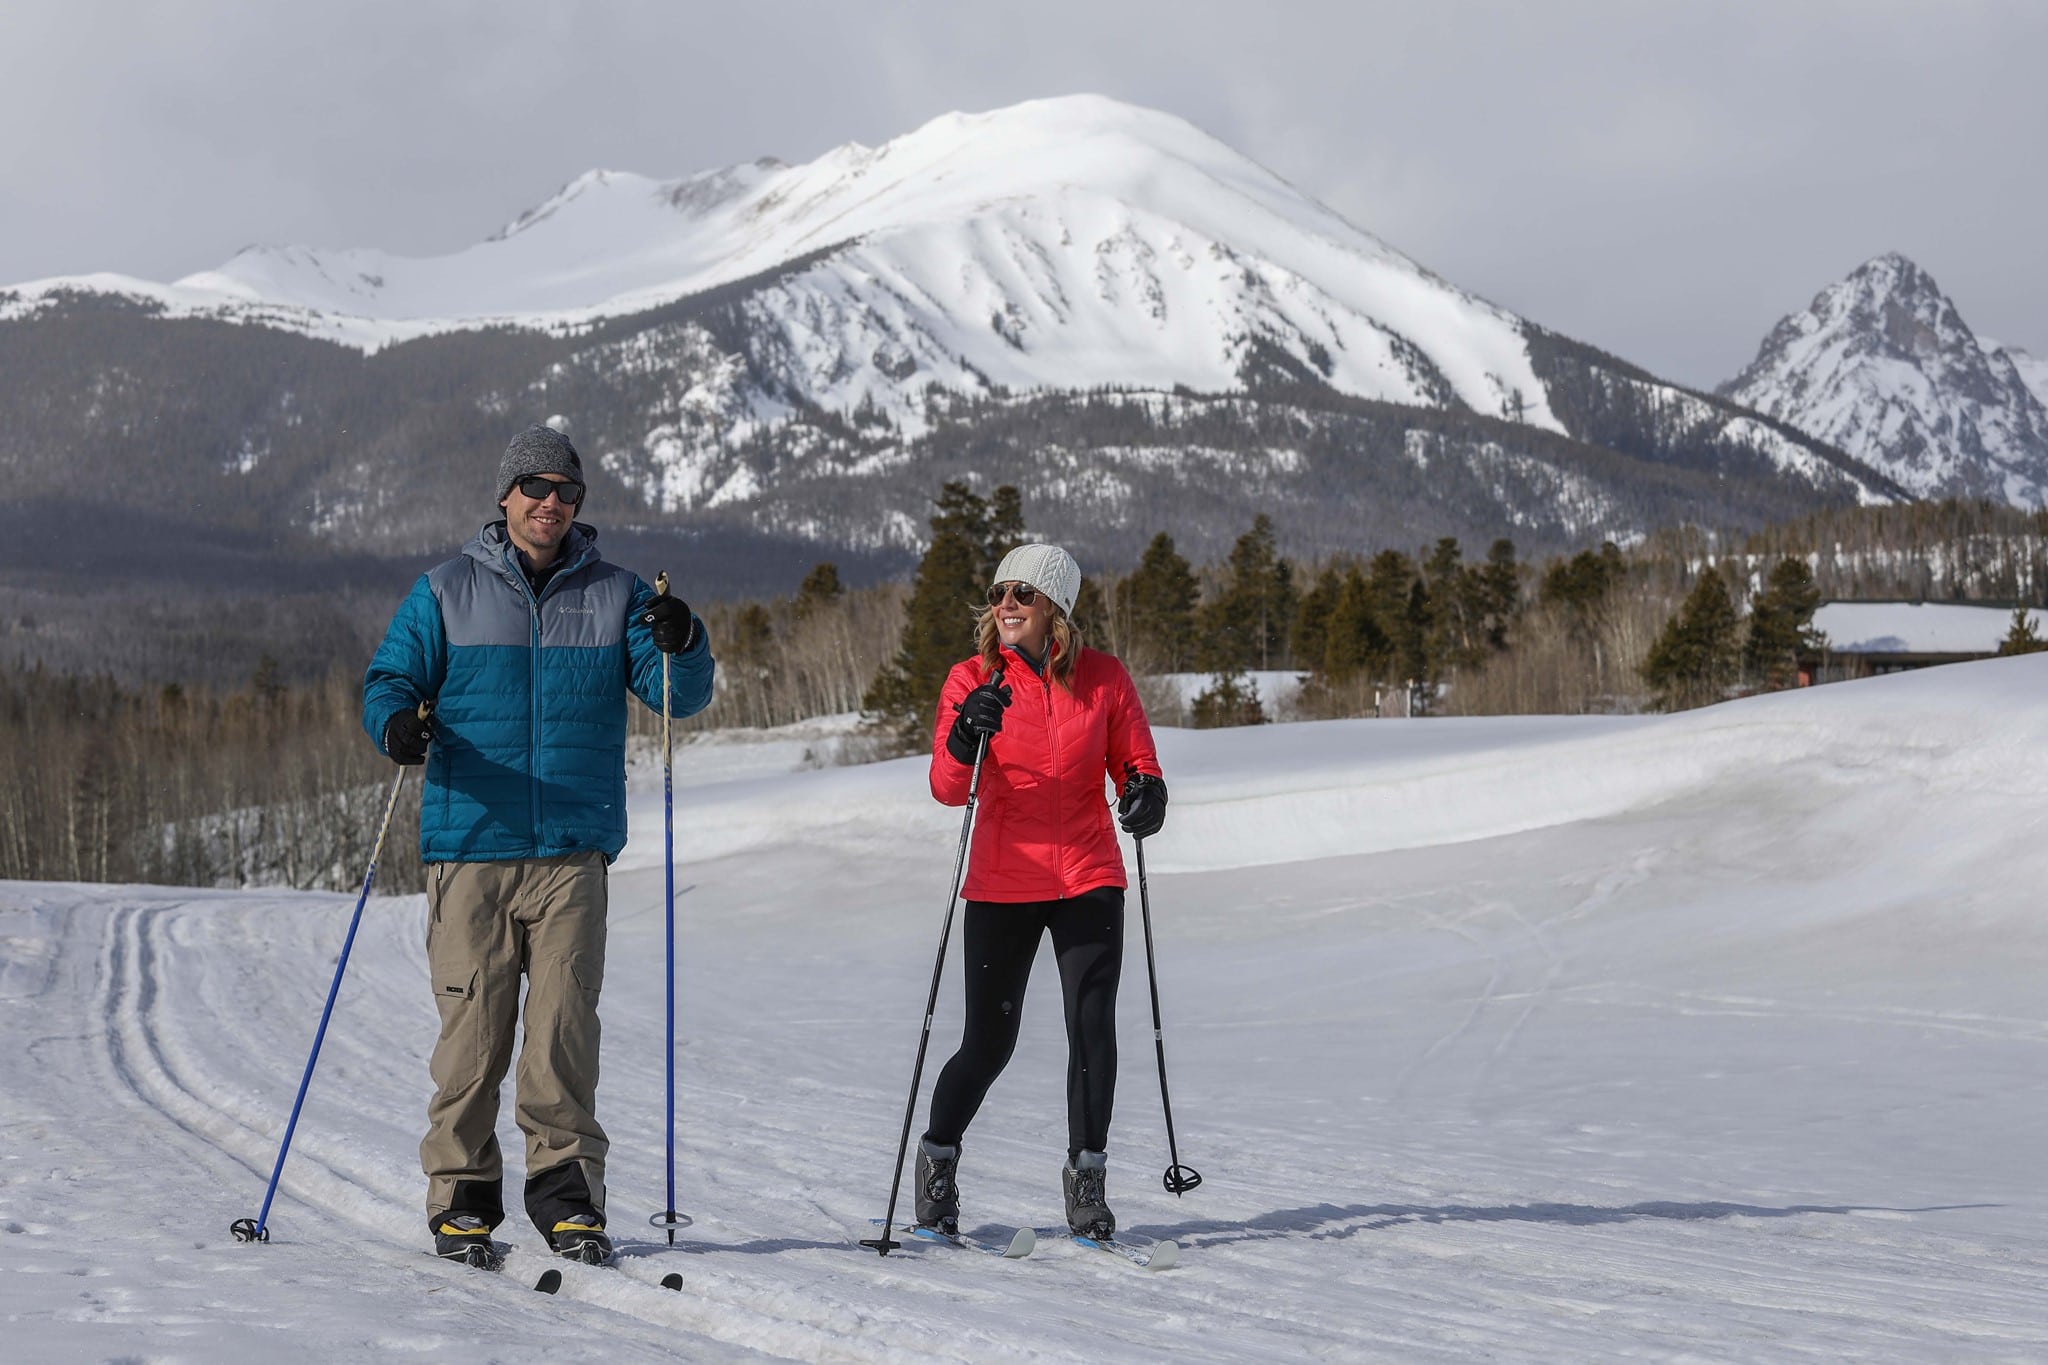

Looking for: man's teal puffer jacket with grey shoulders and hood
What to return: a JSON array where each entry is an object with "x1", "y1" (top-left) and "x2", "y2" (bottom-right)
[{"x1": 362, "y1": 522, "x2": 713, "y2": 864}]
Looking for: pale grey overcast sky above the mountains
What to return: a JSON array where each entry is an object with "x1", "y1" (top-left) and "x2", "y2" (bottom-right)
[{"x1": 0, "y1": 0, "x2": 2048, "y2": 387}]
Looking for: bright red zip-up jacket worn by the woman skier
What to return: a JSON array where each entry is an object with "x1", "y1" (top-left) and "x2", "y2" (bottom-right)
[{"x1": 932, "y1": 649, "x2": 1163, "y2": 900}]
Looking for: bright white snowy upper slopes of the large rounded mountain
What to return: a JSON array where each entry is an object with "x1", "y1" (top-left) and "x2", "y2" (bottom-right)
[{"x1": 0, "y1": 96, "x2": 1561, "y2": 430}]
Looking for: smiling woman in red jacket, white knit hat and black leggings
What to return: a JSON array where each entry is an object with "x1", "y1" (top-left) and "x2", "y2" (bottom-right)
[{"x1": 918, "y1": 544, "x2": 1165, "y2": 1238}]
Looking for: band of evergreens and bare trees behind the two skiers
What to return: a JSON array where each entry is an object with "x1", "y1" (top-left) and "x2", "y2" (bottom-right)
[{"x1": 0, "y1": 491, "x2": 2048, "y2": 890}]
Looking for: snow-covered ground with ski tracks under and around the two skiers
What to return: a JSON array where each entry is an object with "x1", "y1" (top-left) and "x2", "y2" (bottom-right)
[{"x1": 0, "y1": 655, "x2": 2048, "y2": 1361}]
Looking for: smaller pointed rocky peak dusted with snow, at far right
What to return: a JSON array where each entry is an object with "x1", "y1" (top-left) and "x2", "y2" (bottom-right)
[{"x1": 1720, "y1": 252, "x2": 2048, "y2": 505}]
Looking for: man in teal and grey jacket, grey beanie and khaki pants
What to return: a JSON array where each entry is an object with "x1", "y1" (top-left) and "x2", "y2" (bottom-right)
[{"x1": 362, "y1": 426, "x2": 713, "y2": 1267}]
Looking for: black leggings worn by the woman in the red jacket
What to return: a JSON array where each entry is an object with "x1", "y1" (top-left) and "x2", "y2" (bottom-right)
[{"x1": 924, "y1": 886, "x2": 1124, "y2": 1152}]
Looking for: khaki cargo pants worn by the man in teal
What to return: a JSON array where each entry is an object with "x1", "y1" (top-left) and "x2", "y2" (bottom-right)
[{"x1": 420, "y1": 851, "x2": 610, "y2": 1232}]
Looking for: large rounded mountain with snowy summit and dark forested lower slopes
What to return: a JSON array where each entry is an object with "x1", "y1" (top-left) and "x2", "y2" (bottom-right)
[{"x1": 0, "y1": 96, "x2": 1901, "y2": 581}]
